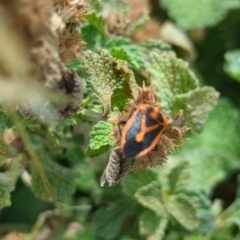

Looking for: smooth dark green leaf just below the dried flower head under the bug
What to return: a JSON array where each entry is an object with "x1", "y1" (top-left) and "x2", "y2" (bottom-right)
[{"x1": 122, "y1": 171, "x2": 157, "y2": 196}]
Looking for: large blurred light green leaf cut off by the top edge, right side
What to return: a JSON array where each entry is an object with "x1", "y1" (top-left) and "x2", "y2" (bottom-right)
[{"x1": 161, "y1": 0, "x2": 227, "y2": 29}]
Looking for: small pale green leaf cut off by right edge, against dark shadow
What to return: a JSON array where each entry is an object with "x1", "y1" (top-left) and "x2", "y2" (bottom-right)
[{"x1": 224, "y1": 49, "x2": 240, "y2": 82}]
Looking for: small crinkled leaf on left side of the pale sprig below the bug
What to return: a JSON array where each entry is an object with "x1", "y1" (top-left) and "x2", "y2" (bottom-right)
[{"x1": 135, "y1": 181, "x2": 164, "y2": 215}]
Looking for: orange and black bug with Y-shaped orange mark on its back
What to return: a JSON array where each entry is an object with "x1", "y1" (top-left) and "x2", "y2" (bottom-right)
[{"x1": 121, "y1": 103, "x2": 168, "y2": 158}]
